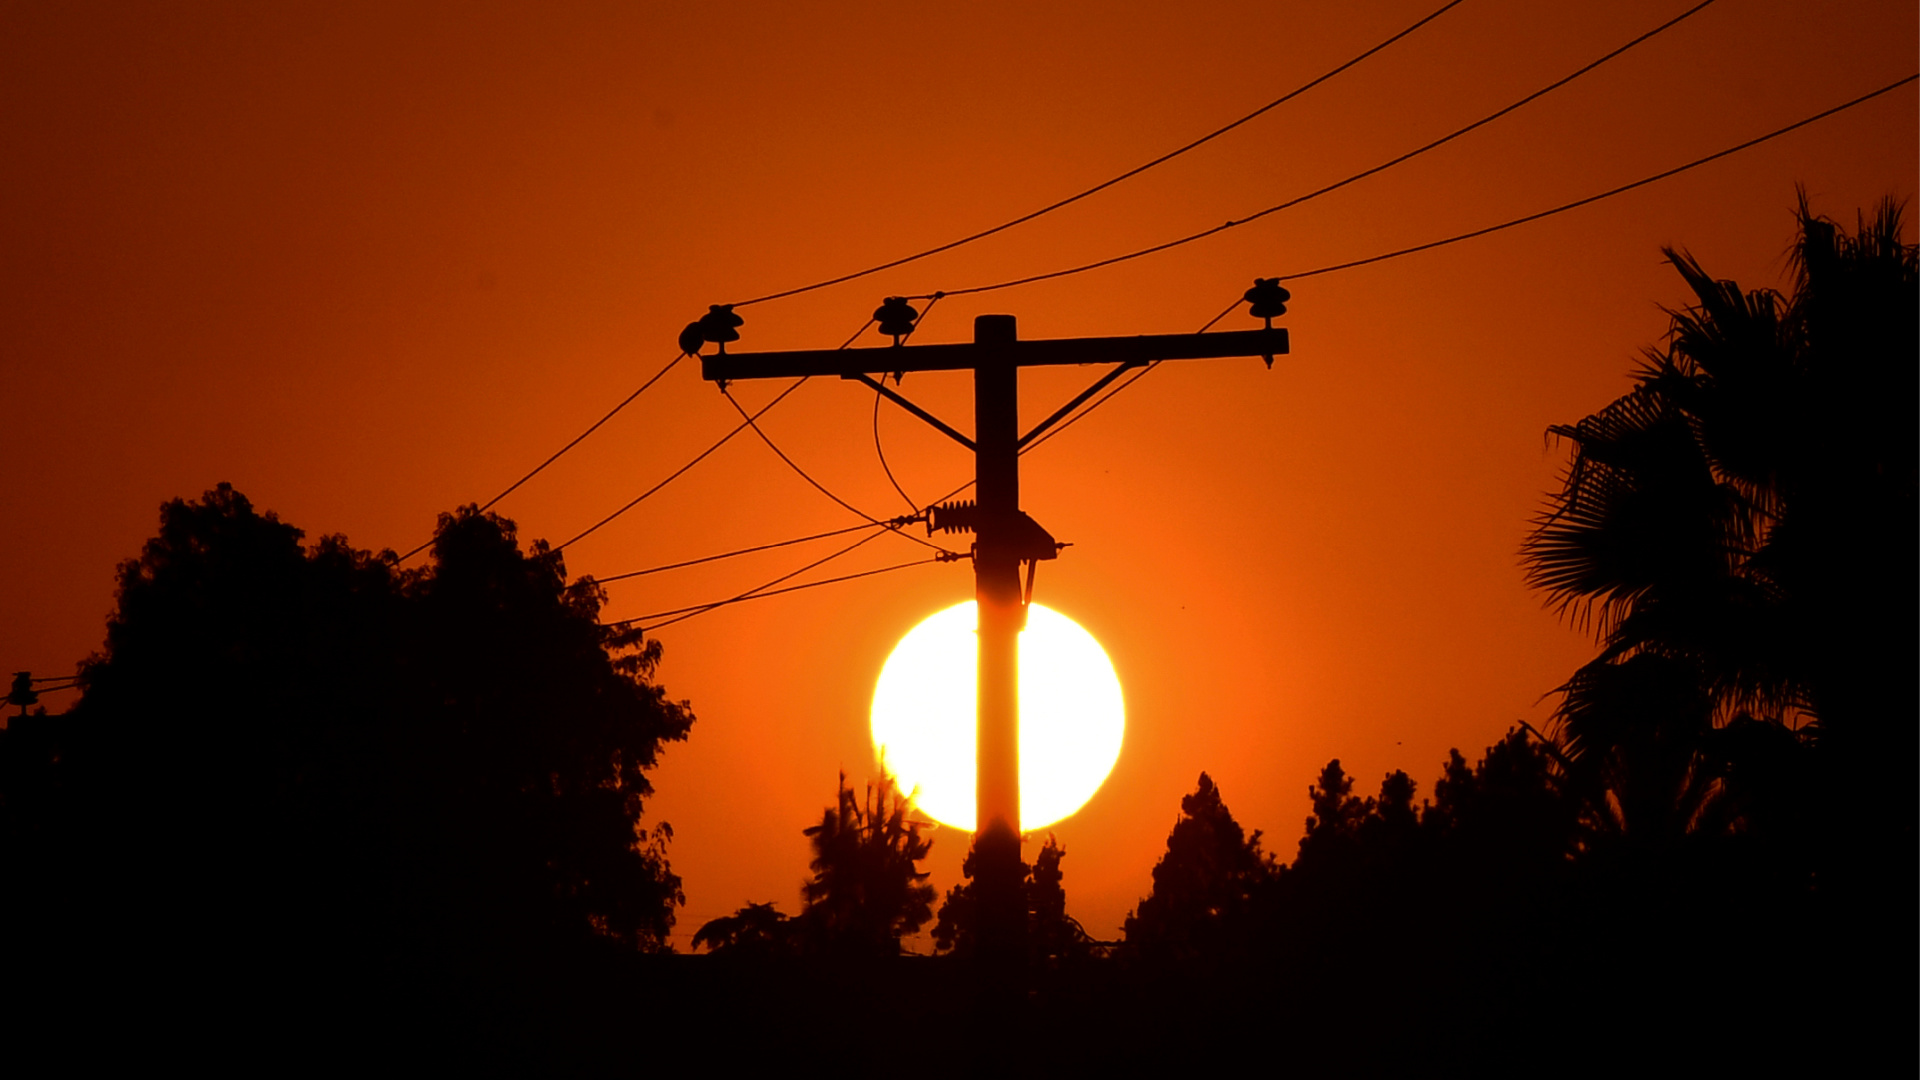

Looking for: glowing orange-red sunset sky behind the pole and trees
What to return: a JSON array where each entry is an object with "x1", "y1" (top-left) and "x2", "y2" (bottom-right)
[{"x1": 0, "y1": 0, "x2": 1920, "y2": 936}]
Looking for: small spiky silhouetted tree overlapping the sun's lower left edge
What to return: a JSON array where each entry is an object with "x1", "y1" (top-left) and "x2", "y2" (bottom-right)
[{"x1": 793, "y1": 773, "x2": 935, "y2": 959}]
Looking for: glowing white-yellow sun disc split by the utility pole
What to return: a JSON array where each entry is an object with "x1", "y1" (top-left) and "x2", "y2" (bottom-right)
[{"x1": 872, "y1": 600, "x2": 1127, "y2": 832}]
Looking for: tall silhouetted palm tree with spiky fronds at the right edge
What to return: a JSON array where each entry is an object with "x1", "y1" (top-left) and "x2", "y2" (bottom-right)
[{"x1": 1523, "y1": 192, "x2": 1920, "y2": 847}]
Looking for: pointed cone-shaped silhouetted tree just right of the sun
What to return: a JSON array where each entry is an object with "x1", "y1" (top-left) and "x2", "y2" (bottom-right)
[{"x1": 1123, "y1": 773, "x2": 1275, "y2": 961}]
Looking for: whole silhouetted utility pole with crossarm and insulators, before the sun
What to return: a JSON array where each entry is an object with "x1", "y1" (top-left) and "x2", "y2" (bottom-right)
[{"x1": 698, "y1": 307, "x2": 1288, "y2": 988}]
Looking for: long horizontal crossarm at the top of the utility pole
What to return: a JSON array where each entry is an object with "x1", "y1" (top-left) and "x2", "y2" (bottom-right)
[{"x1": 701, "y1": 327, "x2": 1288, "y2": 382}]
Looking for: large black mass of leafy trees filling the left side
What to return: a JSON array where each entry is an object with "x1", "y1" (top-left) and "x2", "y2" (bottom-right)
[{"x1": 0, "y1": 484, "x2": 693, "y2": 978}]
